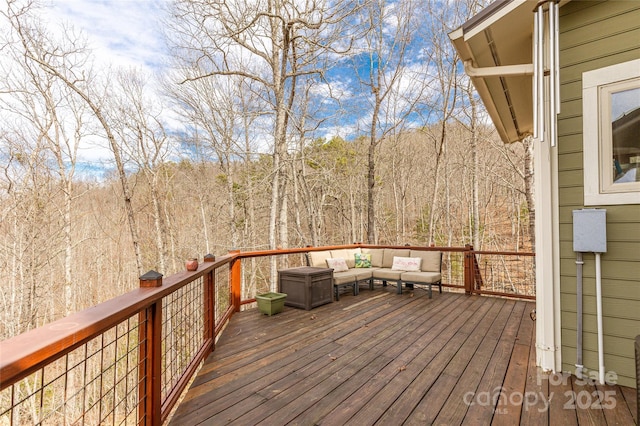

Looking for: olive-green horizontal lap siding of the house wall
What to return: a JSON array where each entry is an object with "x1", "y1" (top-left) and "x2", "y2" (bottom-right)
[{"x1": 557, "y1": 1, "x2": 640, "y2": 387}]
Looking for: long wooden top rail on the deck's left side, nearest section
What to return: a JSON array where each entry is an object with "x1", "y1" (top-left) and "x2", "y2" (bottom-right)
[{"x1": 0, "y1": 255, "x2": 235, "y2": 390}]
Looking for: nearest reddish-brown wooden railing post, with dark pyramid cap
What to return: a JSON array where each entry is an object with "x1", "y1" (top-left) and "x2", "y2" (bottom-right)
[{"x1": 138, "y1": 271, "x2": 162, "y2": 426}]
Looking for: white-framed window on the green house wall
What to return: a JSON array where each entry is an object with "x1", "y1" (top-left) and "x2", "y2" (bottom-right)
[{"x1": 582, "y1": 60, "x2": 640, "y2": 206}]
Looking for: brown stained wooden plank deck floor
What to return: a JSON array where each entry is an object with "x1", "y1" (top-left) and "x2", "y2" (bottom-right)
[{"x1": 171, "y1": 287, "x2": 637, "y2": 426}]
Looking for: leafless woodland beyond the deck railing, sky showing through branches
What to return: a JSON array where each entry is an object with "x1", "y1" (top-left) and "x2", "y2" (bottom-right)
[{"x1": 0, "y1": 0, "x2": 535, "y2": 340}]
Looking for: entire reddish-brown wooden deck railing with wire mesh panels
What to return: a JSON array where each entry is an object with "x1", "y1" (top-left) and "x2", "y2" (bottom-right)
[{"x1": 0, "y1": 244, "x2": 535, "y2": 425}]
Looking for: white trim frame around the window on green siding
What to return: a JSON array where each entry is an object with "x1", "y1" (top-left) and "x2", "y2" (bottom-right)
[{"x1": 582, "y1": 59, "x2": 640, "y2": 206}]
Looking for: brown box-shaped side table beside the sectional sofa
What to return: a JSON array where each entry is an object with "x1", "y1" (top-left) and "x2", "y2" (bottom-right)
[{"x1": 278, "y1": 266, "x2": 333, "y2": 310}]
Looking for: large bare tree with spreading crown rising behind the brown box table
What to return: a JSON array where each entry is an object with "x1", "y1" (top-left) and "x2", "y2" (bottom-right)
[{"x1": 168, "y1": 0, "x2": 353, "y2": 248}]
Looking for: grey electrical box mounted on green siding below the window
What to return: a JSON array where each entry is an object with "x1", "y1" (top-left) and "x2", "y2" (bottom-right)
[{"x1": 573, "y1": 209, "x2": 607, "y2": 253}]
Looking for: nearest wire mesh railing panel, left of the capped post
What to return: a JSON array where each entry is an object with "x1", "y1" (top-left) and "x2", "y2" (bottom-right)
[{"x1": 0, "y1": 315, "x2": 139, "y2": 425}]
